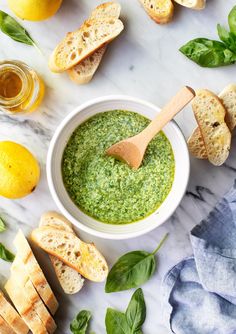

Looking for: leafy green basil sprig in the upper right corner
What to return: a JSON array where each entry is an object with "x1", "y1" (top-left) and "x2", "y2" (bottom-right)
[{"x1": 179, "y1": 6, "x2": 236, "y2": 68}]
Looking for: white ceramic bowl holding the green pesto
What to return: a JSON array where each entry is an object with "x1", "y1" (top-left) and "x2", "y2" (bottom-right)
[{"x1": 47, "y1": 95, "x2": 190, "y2": 239}]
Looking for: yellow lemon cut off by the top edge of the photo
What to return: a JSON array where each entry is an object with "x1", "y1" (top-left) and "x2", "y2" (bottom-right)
[{"x1": 8, "y1": 0, "x2": 62, "y2": 21}]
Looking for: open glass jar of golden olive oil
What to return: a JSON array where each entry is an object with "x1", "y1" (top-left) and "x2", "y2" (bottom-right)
[{"x1": 0, "y1": 61, "x2": 44, "y2": 114}]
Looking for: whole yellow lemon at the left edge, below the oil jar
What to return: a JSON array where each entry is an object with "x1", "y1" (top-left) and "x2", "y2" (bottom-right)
[{"x1": 0, "y1": 141, "x2": 40, "y2": 199}]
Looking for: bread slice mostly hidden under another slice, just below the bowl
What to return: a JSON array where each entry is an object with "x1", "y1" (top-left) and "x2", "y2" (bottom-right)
[{"x1": 39, "y1": 211, "x2": 84, "y2": 294}]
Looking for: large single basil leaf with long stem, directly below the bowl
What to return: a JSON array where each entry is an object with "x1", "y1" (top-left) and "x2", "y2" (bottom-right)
[{"x1": 105, "y1": 234, "x2": 168, "y2": 293}]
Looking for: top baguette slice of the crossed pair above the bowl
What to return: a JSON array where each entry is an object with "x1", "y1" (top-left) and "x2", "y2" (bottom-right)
[{"x1": 49, "y1": 18, "x2": 124, "y2": 73}]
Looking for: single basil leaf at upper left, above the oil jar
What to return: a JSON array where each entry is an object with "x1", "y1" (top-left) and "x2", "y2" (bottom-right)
[{"x1": 0, "y1": 10, "x2": 35, "y2": 45}]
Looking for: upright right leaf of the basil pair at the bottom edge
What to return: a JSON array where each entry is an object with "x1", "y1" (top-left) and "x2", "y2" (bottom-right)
[{"x1": 125, "y1": 289, "x2": 146, "y2": 333}]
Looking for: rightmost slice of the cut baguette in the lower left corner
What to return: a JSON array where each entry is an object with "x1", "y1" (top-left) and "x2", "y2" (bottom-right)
[{"x1": 13, "y1": 230, "x2": 58, "y2": 314}]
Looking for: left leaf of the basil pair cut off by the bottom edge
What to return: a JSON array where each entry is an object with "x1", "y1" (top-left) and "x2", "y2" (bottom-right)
[{"x1": 105, "y1": 308, "x2": 132, "y2": 334}]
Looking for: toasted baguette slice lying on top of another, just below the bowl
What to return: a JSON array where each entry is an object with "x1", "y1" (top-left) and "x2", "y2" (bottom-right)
[{"x1": 31, "y1": 226, "x2": 108, "y2": 282}]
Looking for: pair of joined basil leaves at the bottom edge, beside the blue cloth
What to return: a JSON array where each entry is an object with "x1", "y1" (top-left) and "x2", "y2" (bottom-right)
[{"x1": 105, "y1": 289, "x2": 146, "y2": 334}]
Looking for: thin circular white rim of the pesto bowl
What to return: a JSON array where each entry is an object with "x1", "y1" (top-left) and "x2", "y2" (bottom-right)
[{"x1": 46, "y1": 95, "x2": 190, "y2": 240}]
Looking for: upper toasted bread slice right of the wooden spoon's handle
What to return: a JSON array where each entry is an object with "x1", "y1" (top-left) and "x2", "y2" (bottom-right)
[{"x1": 192, "y1": 89, "x2": 231, "y2": 166}]
